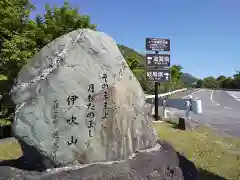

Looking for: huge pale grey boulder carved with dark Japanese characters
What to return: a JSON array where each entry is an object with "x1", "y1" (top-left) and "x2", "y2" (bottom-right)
[{"x1": 11, "y1": 29, "x2": 156, "y2": 167}]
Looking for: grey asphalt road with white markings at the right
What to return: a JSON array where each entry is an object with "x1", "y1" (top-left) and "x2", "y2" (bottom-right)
[{"x1": 174, "y1": 89, "x2": 240, "y2": 137}]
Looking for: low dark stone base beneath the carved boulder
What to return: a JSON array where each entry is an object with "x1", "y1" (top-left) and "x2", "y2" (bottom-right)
[{"x1": 0, "y1": 140, "x2": 197, "y2": 180}]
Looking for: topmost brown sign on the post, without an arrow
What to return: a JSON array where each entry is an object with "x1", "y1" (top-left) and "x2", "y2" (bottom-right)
[{"x1": 146, "y1": 38, "x2": 170, "y2": 51}]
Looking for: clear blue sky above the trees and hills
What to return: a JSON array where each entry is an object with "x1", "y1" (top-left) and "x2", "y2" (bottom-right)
[{"x1": 31, "y1": 0, "x2": 240, "y2": 78}]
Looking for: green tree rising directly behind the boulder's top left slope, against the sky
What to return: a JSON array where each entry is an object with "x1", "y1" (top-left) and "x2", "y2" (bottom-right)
[{"x1": 32, "y1": 0, "x2": 97, "y2": 49}]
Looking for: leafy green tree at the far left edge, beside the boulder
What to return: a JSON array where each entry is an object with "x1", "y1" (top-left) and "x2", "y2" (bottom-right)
[{"x1": 0, "y1": 0, "x2": 36, "y2": 81}]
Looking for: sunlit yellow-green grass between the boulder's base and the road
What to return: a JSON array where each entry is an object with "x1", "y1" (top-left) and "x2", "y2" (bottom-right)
[{"x1": 154, "y1": 123, "x2": 240, "y2": 180}]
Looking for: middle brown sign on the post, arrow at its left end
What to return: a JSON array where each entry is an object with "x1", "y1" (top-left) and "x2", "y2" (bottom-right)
[{"x1": 146, "y1": 54, "x2": 170, "y2": 67}]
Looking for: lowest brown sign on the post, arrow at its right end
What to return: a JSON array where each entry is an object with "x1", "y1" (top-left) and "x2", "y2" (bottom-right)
[{"x1": 146, "y1": 68, "x2": 171, "y2": 82}]
